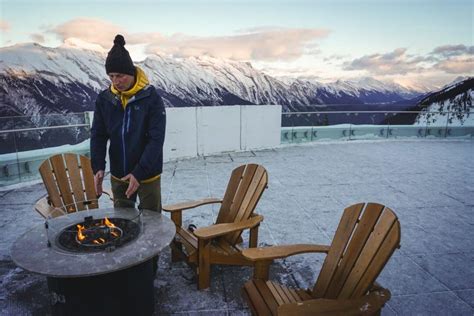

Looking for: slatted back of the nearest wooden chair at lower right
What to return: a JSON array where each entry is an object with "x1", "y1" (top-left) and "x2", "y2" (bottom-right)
[{"x1": 312, "y1": 203, "x2": 400, "y2": 299}]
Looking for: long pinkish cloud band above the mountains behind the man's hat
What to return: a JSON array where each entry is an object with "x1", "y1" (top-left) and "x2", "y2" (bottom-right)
[{"x1": 50, "y1": 18, "x2": 329, "y2": 61}]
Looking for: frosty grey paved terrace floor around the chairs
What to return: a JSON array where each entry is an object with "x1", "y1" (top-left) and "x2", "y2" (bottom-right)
[{"x1": 0, "y1": 140, "x2": 474, "y2": 315}]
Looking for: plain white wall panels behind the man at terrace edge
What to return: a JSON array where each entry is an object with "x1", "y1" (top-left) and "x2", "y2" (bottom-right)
[{"x1": 163, "y1": 105, "x2": 281, "y2": 161}]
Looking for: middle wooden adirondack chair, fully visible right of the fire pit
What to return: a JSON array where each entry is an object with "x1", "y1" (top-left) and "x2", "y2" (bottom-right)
[{"x1": 163, "y1": 164, "x2": 268, "y2": 289}]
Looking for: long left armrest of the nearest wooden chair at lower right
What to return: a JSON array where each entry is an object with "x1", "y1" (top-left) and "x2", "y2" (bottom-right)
[{"x1": 242, "y1": 244, "x2": 329, "y2": 261}]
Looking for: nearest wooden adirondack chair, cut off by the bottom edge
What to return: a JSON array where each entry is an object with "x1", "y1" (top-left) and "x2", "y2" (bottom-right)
[{"x1": 242, "y1": 203, "x2": 400, "y2": 315}]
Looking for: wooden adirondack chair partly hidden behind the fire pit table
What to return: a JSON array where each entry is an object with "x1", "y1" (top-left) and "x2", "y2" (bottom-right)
[{"x1": 35, "y1": 153, "x2": 112, "y2": 218}]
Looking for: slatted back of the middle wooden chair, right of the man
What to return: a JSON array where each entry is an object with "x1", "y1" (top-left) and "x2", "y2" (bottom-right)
[{"x1": 216, "y1": 164, "x2": 268, "y2": 245}]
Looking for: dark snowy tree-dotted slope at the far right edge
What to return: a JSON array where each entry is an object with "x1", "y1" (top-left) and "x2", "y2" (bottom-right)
[{"x1": 416, "y1": 77, "x2": 474, "y2": 126}]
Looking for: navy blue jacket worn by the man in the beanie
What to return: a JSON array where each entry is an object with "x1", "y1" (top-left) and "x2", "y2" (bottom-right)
[{"x1": 91, "y1": 86, "x2": 166, "y2": 181}]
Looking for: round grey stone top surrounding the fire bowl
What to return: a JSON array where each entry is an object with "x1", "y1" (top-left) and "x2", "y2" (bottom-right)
[{"x1": 11, "y1": 208, "x2": 175, "y2": 278}]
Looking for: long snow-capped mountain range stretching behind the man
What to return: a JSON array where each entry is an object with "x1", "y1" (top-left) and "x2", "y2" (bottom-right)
[{"x1": 0, "y1": 44, "x2": 419, "y2": 116}]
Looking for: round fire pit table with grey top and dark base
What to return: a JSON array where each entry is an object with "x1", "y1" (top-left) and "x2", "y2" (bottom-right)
[{"x1": 11, "y1": 202, "x2": 175, "y2": 316}]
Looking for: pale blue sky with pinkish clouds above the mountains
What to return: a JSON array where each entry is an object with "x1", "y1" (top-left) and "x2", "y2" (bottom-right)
[{"x1": 0, "y1": 0, "x2": 474, "y2": 87}]
